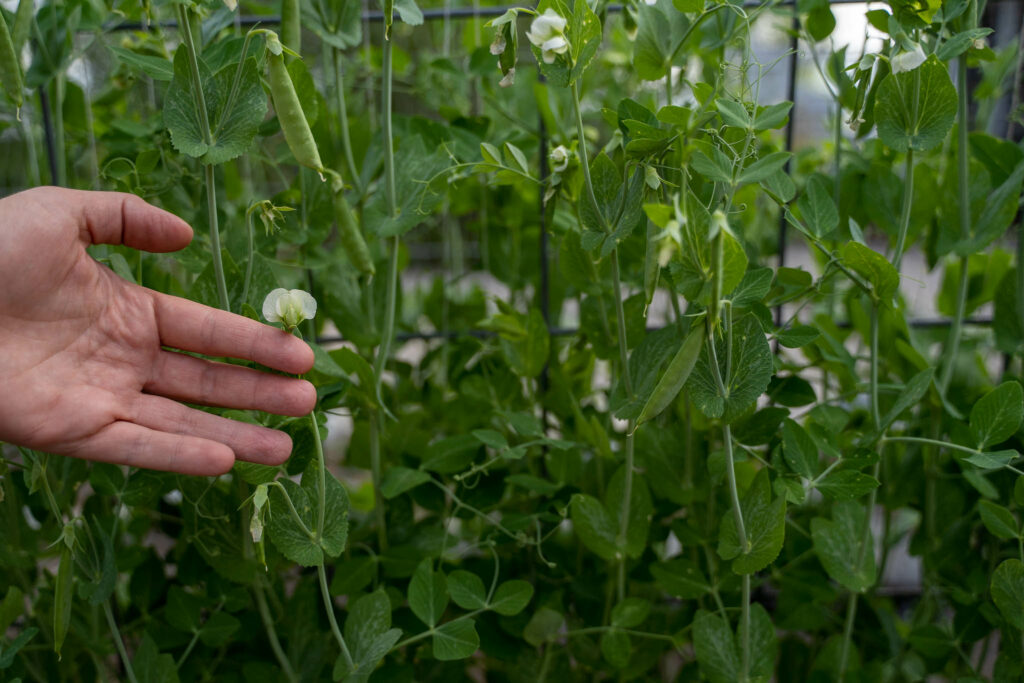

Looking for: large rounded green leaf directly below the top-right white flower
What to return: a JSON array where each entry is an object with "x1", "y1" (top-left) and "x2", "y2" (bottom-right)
[{"x1": 874, "y1": 57, "x2": 956, "y2": 152}]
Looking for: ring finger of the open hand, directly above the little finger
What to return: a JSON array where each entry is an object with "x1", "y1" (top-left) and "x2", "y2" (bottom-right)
[{"x1": 131, "y1": 394, "x2": 292, "y2": 469}]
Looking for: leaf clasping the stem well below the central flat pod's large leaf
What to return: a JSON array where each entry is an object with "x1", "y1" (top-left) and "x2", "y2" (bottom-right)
[{"x1": 718, "y1": 470, "x2": 785, "y2": 574}]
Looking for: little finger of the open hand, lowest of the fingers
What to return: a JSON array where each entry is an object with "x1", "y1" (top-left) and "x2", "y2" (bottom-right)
[{"x1": 68, "y1": 422, "x2": 234, "y2": 476}]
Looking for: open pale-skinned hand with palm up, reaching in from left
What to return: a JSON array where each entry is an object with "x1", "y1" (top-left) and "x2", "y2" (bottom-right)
[{"x1": 0, "y1": 187, "x2": 316, "y2": 475}]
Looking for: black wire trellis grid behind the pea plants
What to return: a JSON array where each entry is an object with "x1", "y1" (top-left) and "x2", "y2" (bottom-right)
[{"x1": 39, "y1": 0, "x2": 1010, "y2": 352}]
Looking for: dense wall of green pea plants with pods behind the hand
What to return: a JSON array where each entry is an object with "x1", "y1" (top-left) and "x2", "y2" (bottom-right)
[{"x1": 0, "y1": 0, "x2": 1024, "y2": 683}]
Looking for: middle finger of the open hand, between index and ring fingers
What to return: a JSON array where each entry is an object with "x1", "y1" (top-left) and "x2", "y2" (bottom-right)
[{"x1": 143, "y1": 351, "x2": 316, "y2": 417}]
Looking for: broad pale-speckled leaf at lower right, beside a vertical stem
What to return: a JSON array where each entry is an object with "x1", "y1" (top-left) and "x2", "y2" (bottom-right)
[{"x1": 811, "y1": 502, "x2": 878, "y2": 593}]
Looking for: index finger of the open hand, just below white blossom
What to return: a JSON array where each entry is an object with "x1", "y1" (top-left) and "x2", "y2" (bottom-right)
[{"x1": 152, "y1": 292, "x2": 313, "y2": 375}]
